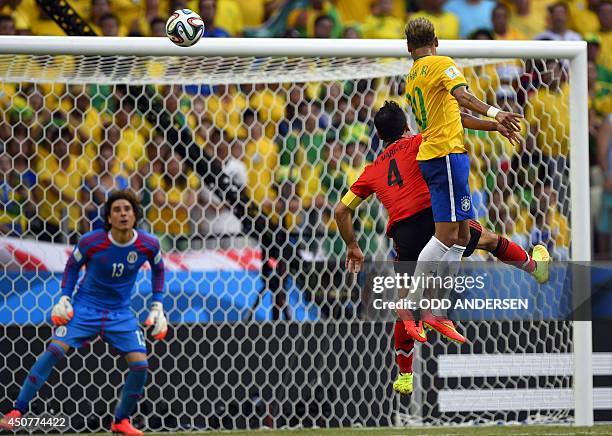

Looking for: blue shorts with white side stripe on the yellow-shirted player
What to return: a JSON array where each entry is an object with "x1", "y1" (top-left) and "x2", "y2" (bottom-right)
[{"x1": 419, "y1": 153, "x2": 474, "y2": 223}]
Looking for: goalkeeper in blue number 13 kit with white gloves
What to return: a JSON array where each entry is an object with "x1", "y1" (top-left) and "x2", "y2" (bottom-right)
[{"x1": 0, "y1": 191, "x2": 168, "y2": 436}]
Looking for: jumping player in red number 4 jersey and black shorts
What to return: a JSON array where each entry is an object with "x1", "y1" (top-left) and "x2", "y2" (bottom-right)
[{"x1": 335, "y1": 102, "x2": 549, "y2": 394}]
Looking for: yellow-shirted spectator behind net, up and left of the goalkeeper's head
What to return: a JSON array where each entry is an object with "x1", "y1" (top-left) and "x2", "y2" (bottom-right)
[{"x1": 32, "y1": 124, "x2": 82, "y2": 242}]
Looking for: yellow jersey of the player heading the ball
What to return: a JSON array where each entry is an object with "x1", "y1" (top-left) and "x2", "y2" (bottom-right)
[{"x1": 406, "y1": 56, "x2": 467, "y2": 160}]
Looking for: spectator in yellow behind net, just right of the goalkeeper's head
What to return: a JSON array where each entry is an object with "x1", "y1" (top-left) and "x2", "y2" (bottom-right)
[{"x1": 147, "y1": 153, "x2": 200, "y2": 251}]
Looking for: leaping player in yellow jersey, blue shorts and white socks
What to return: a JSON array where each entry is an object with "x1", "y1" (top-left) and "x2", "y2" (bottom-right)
[{"x1": 406, "y1": 18, "x2": 548, "y2": 339}]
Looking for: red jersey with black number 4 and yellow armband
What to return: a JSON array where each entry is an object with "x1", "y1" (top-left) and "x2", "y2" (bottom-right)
[{"x1": 342, "y1": 134, "x2": 431, "y2": 234}]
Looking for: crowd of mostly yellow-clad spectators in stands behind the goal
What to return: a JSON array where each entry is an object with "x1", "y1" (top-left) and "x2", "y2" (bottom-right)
[{"x1": 0, "y1": 0, "x2": 612, "y2": 258}]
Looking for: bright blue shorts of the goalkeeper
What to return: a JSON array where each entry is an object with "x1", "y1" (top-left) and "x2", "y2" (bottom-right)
[{"x1": 53, "y1": 304, "x2": 147, "y2": 354}]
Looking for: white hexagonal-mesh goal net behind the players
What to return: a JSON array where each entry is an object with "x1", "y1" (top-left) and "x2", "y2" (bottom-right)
[{"x1": 0, "y1": 38, "x2": 590, "y2": 432}]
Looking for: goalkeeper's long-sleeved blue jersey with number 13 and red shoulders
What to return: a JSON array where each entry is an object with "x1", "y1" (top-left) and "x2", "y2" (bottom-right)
[{"x1": 62, "y1": 229, "x2": 164, "y2": 310}]
